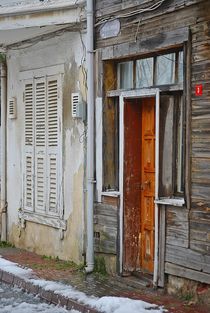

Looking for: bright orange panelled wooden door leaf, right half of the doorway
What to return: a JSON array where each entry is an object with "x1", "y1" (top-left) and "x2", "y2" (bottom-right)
[{"x1": 141, "y1": 98, "x2": 155, "y2": 273}]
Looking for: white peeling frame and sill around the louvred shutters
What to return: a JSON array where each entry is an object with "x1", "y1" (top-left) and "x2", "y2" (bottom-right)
[{"x1": 19, "y1": 65, "x2": 67, "y2": 230}]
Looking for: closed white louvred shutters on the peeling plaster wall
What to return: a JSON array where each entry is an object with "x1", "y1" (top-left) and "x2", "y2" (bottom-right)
[{"x1": 24, "y1": 77, "x2": 62, "y2": 216}]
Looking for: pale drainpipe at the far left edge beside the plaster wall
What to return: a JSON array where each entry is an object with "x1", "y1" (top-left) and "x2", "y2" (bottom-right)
[{"x1": 0, "y1": 63, "x2": 7, "y2": 241}]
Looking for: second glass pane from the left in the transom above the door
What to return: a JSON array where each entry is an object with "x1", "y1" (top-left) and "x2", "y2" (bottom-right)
[{"x1": 136, "y1": 58, "x2": 153, "y2": 88}]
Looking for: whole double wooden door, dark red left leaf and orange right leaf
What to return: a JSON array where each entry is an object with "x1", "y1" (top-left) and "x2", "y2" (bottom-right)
[{"x1": 123, "y1": 98, "x2": 155, "y2": 273}]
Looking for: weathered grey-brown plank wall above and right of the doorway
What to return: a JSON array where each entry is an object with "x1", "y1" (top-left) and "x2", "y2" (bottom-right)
[{"x1": 96, "y1": 0, "x2": 210, "y2": 283}]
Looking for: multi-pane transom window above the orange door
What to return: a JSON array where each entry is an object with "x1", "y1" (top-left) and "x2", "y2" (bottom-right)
[{"x1": 117, "y1": 51, "x2": 184, "y2": 89}]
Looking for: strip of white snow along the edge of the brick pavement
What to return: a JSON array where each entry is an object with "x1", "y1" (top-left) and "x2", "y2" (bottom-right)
[{"x1": 0, "y1": 257, "x2": 165, "y2": 313}]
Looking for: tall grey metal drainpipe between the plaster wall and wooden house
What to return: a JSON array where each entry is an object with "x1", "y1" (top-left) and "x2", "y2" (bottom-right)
[{"x1": 86, "y1": 0, "x2": 95, "y2": 273}]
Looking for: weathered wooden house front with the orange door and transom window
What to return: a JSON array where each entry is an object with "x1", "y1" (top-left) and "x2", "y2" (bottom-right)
[{"x1": 94, "y1": 0, "x2": 210, "y2": 292}]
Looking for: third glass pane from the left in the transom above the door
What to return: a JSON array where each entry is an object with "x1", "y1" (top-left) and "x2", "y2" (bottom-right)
[{"x1": 155, "y1": 53, "x2": 175, "y2": 85}]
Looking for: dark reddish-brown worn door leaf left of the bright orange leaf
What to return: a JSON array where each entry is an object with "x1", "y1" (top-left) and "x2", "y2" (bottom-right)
[{"x1": 123, "y1": 100, "x2": 141, "y2": 271}]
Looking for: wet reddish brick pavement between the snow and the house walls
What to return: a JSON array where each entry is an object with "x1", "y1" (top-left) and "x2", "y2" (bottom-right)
[{"x1": 0, "y1": 248, "x2": 210, "y2": 313}]
